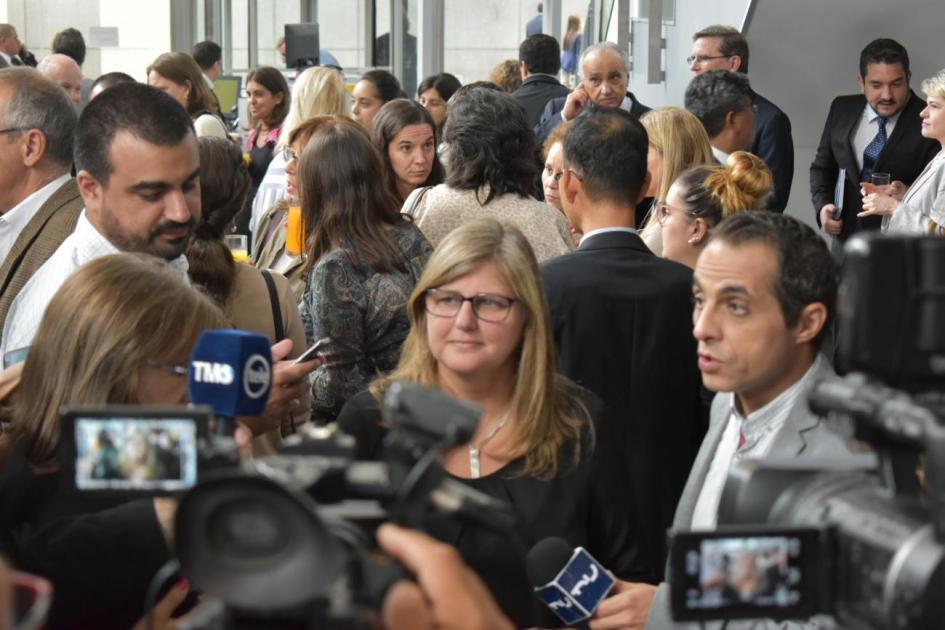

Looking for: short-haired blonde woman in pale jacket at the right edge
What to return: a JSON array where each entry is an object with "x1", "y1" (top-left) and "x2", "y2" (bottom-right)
[{"x1": 858, "y1": 70, "x2": 945, "y2": 236}]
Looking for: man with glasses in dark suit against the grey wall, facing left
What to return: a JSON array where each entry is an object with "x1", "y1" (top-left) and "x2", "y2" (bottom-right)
[{"x1": 686, "y1": 25, "x2": 794, "y2": 212}]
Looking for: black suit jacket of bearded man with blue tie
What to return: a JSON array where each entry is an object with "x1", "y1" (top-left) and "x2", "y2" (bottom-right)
[{"x1": 810, "y1": 91, "x2": 941, "y2": 239}]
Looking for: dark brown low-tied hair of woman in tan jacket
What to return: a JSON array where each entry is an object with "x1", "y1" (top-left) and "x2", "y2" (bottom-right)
[{"x1": 187, "y1": 136, "x2": 251, "y2": 307}]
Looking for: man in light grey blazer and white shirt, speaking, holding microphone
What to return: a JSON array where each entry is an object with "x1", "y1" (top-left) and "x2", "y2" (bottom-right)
[{"x1": 595, "y1": 212, "x2": 868, "y2": 630}]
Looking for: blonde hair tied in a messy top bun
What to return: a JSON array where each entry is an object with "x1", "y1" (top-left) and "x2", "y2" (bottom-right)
[{"x1": 676, "y1": 151, "x2": 773, "y2": 228}]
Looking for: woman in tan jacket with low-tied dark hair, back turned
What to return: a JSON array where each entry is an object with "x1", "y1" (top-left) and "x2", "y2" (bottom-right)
[{"x1": 187, "y1": 137, "x2": 314, "y2": 453}]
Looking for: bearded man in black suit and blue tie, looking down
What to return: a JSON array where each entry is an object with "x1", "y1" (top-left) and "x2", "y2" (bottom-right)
[{"x1": 810, "y1": 39, "x2": 941, "y2": 240}]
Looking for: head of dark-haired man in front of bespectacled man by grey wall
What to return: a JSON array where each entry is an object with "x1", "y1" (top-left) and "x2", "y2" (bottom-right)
[{"x1": 686, "y1": 70, "x2": 755, "y2": 164}]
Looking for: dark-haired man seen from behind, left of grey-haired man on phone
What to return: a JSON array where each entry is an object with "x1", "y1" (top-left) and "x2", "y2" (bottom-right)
[{"x1": 512, "y1": 34, "x2": 568, "y2": 127}]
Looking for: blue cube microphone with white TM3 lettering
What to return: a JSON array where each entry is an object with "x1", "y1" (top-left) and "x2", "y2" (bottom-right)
[{"x1": 188, "y1": 329, "x2": 272, "y2": 430}]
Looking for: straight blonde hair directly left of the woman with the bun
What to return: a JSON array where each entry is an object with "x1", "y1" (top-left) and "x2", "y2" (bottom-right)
[{"x1": 640, "y1": 107, "x2": 715, "y2": 201}]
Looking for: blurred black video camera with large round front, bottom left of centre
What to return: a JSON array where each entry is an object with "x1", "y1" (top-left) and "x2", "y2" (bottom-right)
[{"x1": 165, "y1": 383, "x2": 514, "y2": 629}]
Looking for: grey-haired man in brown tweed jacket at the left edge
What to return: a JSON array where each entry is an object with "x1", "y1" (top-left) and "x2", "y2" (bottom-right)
[{"x1": 0, "y1": 68, "x2": 83, "y2": 330}]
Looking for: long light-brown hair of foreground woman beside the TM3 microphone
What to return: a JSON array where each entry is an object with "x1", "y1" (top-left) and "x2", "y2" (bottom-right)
[{"x1": 12, "y1": 254, "x2": 228, "y2": 465}]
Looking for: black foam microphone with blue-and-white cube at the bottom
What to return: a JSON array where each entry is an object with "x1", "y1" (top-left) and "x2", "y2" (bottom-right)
[{"x1": 525, "y1": 537, "x2": 616, "y2": 626}]
